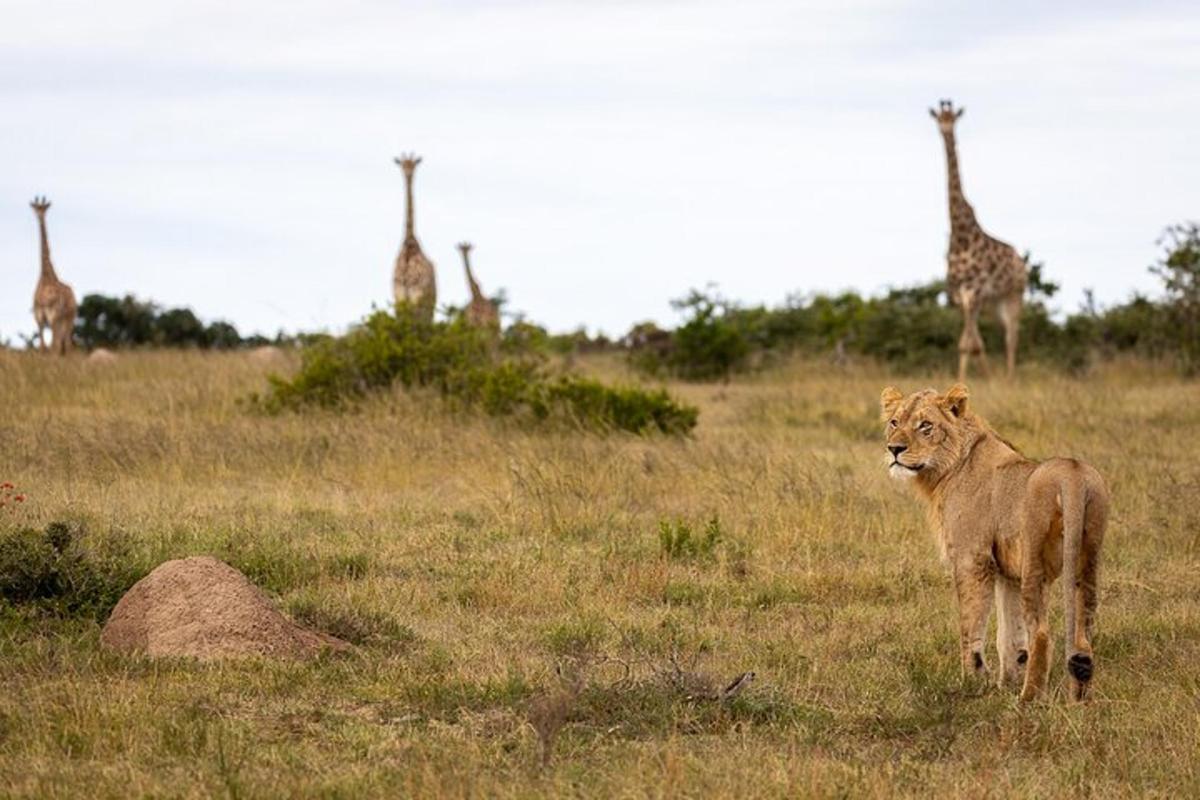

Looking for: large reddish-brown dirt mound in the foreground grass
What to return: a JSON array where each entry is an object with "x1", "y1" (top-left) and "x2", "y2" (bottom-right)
[{"x1": 100, "y1": 555, "x2": 350, "y2": 660}]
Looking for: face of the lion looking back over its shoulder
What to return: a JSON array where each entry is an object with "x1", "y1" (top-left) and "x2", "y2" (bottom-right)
[{"x1": 880, "y1": 384, "x2": 967, "y2": 482}]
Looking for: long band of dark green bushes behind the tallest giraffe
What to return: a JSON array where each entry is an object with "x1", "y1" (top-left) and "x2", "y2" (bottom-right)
[{"x1": 624, "y1": 237, "x2": 1200, "y2": 380}]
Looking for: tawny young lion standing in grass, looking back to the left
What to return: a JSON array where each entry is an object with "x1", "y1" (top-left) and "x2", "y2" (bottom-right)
[{"x1": 880, "y1": 384, "x2": 1109, "y2": 700}]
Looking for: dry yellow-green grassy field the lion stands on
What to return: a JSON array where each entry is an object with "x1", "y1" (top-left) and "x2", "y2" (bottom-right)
[{"x1": 0, "y1": 353, "x2": 1200, "y2": 798}]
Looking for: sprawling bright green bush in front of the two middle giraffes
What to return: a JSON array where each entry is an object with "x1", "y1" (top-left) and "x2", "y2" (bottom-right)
[{"x1": 258, "y1": 307, "x2": 698, "y2": 433}]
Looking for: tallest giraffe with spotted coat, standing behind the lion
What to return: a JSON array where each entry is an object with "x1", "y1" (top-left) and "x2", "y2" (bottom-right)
[{"x1": 929, "y1": 100, "x2": 1027, "y2": 380}]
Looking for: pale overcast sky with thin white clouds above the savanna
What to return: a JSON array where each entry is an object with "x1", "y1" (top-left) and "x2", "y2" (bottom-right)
[{"x1": 0, "y1": 0, "x2": 1200, "y2": 341}]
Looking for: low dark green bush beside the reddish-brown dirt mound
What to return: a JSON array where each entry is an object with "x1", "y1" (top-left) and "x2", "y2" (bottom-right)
[{"x1": 0, "y1": 522, "x2": 144, "y2": 620}]
